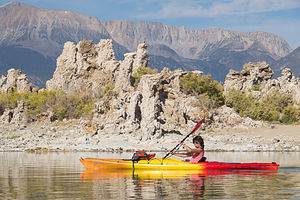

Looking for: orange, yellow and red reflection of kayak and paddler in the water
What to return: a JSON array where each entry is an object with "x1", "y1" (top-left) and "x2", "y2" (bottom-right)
[{"x1": 80, "y1": 169, "x2": 277, "y2": 199}]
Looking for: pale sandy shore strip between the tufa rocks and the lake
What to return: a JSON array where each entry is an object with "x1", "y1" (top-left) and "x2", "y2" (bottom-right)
[{"x1": 0, "y1": 121, "x2": 300, "y2": 152}]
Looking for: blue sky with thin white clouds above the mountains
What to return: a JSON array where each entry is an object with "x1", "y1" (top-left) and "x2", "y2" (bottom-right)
[{"x1": 0, "y1": 0, "x2": 300, "y2": 49}]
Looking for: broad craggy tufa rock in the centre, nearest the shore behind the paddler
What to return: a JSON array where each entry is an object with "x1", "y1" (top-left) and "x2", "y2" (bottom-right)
[{"x1": 93, "y1": 68, "x2": 209, "y2": 140}]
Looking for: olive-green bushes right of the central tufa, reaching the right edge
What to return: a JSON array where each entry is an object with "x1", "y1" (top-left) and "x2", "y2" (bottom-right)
[{"x1": 180, "y1": 72, "x2": 300, "y2": 124}]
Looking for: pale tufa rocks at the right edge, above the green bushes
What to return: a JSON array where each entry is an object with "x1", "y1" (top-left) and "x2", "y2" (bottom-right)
[{"x1": 224, "y1": 62, "x2": 300, "y2": 103}]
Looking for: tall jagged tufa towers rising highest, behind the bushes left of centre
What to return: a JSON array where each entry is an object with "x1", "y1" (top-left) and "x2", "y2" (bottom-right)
[{"x1": 46, "y1": 39, "x2": 148, "y2": 97}]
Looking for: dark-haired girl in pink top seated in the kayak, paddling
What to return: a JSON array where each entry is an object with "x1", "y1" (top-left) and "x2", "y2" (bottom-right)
[{"x1": 169, "y1": 136, "x2": 206, "y2": 163}]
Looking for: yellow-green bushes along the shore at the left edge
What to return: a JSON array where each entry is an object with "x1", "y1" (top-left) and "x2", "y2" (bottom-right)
[{"x1": 0, "y1": 90, "x2": 96, "y2": 120}]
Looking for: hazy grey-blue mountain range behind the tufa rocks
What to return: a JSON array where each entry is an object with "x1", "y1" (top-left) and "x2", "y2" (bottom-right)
[{"x1": 0, "y1": 2, "x2": 300, "y2": 87}]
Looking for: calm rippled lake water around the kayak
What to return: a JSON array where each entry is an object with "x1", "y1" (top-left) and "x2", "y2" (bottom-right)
[{"x1": 0, "y1": 152, "x2": 300, "y2": 200}]
